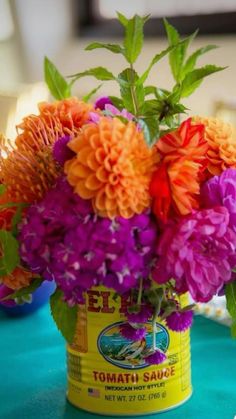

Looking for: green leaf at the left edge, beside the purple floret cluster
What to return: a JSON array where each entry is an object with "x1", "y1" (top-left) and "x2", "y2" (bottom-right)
[{"x1": 0, "y1": 230, "x2": 19, "y2": 276}]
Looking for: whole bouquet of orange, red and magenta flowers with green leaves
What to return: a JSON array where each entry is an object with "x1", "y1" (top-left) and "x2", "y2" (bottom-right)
[{"x1": 0, "y1": 13, "x2": 236, "y2": 364}]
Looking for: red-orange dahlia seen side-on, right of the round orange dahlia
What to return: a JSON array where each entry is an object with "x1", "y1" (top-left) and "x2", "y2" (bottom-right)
[{"x1": 150, "y1": 119, "x2": 208, "y2": 222}]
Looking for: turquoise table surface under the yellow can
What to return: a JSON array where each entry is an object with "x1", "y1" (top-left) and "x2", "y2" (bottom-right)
[{"x1": 0, "y1": 307, "x2": 236, "y2": 419}]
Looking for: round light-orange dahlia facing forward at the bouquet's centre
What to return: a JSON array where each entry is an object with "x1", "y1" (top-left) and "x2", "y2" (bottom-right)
[{"x1": 64, "y1": 117, "x2": 158, "y2": 218}]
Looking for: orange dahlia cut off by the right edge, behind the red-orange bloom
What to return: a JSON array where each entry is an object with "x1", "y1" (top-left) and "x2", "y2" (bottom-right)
[{"x1": 193, "y1": 116, "x2": 236, "y2": 175}]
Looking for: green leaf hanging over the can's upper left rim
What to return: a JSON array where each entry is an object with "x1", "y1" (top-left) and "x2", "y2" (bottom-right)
[{"x1": 50, "y1": 289, "x2": 78, "y2": 343}]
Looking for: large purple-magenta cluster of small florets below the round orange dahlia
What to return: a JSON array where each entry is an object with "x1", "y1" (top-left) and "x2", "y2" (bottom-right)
[{"x1": 19, "y1": 179, "x2": 156, "y2": 305}]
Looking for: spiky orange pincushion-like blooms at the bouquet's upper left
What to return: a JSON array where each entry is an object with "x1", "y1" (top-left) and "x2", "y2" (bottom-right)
[{"x1": 0, "y1": 98, "x2": 92, "y2": 203}]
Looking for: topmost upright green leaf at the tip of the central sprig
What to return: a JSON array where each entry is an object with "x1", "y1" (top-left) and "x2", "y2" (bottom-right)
[{"x1": 124, "y1": 15, "x2": 147, "y2": 64}]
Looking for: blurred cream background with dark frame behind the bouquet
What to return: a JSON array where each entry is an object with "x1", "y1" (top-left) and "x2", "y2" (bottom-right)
[{"x1": 0, "y1": 0, "x2": 236, "y2": 138}]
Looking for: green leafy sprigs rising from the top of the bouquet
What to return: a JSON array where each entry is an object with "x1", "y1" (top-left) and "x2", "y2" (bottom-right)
[{"x1": 42, "y1": 12, "x2": 223, "y2": 146}]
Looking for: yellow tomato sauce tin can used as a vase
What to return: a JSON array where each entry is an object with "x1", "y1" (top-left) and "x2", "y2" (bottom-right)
[{"x1": 67, "y1": 287, "x2": 192, "y2": 416}]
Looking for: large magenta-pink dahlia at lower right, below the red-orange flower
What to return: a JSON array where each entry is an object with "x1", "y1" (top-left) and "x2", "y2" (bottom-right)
[{"x1": 153, "y1": 207, "x2": 236, "y2": 302}]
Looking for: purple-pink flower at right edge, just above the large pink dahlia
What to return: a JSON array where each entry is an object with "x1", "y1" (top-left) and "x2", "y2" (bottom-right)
[{"x1": 200, "y1": 169, "x2": 236, "y2": 232}]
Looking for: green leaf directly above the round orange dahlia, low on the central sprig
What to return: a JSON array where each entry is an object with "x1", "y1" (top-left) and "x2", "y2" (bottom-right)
[{"x1": 117, "y1": 68, "x2": 145, "y2": 115}]
